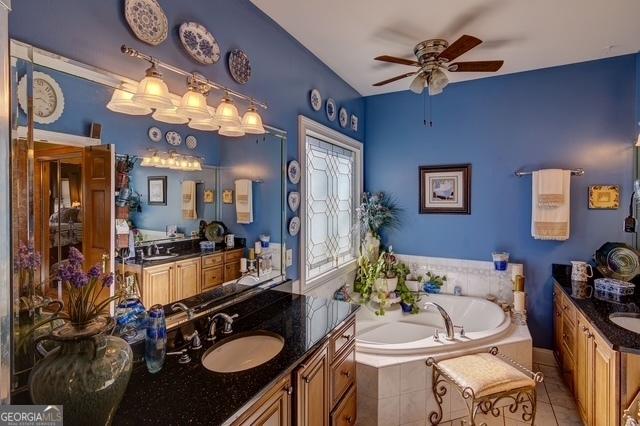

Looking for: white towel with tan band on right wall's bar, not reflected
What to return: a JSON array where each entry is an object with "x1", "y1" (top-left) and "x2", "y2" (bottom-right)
[{"x1": 531, "y1": 170, "x2": 571, "y2": 241}]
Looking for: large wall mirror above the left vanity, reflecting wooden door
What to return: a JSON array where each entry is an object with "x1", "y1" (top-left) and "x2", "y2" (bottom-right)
[{"x1": 11, "y1": 40, "x2": 287, "y2": 391}]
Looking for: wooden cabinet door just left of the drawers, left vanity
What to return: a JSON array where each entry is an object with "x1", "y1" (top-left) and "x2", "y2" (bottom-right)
[{"x1": 296, "y1": 345, "x2": 329, "y2": 426}]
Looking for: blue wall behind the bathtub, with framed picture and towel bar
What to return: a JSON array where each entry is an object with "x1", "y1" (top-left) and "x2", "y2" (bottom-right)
[{"x1": 364, "y1": 55, "x2": 638, "y2": 347}]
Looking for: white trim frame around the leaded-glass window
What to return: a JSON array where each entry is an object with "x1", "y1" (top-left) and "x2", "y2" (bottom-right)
[{"x1": 296, "y1": 115, "x2": 364, "y2": 293}]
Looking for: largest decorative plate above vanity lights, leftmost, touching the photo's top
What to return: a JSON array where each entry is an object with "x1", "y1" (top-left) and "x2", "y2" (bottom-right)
[{"x1": 124, "y1": 0, "x2": 169, "y2": 46}]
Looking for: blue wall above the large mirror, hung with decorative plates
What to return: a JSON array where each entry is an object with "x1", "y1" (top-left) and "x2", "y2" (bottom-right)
[{"x1": 9, "y1": 0, "x2": 364, "y2": 277}]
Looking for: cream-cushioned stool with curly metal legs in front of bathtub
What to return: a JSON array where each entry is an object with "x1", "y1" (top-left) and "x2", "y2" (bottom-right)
[{"x1": 426, "y1": 347, "x2": 543, "y2": 426}]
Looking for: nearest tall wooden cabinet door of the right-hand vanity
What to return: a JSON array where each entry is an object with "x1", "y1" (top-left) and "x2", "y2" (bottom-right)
[{"x1": 591, "y1": 334, "x2": 619, "y2": 426}]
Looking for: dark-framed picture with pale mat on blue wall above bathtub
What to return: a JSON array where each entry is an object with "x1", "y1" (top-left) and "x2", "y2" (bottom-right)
[{"x1": 418, "y1": 164, "x2": 471, "y2": 214}]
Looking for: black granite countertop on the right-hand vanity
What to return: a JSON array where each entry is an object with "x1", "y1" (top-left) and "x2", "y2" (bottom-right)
[{"x1": 552, "y1": 265, "x2": 640, "y2": 354}]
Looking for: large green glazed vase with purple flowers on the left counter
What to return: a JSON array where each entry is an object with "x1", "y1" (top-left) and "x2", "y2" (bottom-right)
[{"x1": 29, "y1": 247, "x2": 133, "y2": 424}]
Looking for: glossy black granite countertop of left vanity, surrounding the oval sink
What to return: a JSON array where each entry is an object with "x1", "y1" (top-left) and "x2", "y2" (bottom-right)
[{"x1": 113, "y1": 290, "x2": 358, "y2": 425}]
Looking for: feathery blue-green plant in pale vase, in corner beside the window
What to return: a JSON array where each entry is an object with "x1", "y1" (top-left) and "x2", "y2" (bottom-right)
[{"x1": 356, "y1": 192, "x2": 400, "y2": 262}]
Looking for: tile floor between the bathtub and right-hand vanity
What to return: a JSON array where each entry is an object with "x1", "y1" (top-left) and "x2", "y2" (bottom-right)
[{"x1": 430, "y1": 352, "x2": 582, "y2": 426}]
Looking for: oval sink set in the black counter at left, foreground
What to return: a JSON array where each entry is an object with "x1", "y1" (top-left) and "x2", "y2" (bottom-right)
[{"x1": 202, "y1": 331, "x2": 284, "y2": 373}]
